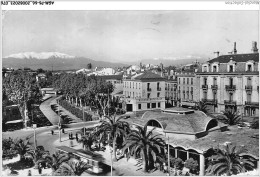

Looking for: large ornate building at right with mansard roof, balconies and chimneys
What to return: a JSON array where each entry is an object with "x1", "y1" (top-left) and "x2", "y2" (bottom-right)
[{"x1": 197, "y1": 42, "x2": 259, "y2": 116}]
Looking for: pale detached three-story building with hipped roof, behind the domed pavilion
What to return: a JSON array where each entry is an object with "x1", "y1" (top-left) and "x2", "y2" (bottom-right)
[{"x1": 123, "y1": 71, "x2": 165, "y2": 112}]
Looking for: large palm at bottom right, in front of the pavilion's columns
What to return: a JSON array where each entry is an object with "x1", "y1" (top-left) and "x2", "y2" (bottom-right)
[{"x1": 206, "y1": 145, "x2": 254, "y2": 176}]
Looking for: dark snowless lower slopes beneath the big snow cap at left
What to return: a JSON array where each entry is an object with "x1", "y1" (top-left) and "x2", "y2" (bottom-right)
[{"x1": 2, "y1": 57, "x2": 127, "y2": 70}]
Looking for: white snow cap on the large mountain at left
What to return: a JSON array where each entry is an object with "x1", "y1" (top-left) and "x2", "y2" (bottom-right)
[{"x1": 5, "y1": 52, "x2": 75, "y2": 59}]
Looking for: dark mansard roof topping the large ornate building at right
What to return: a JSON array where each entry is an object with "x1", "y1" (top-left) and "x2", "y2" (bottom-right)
[{"x1": 208, "y1": 53, "x2": 259, "y2": 63}]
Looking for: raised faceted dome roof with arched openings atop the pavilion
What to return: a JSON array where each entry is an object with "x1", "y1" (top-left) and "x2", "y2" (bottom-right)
[{"x1": 133, "y1": 108, "x2": 223, "y2": 134}]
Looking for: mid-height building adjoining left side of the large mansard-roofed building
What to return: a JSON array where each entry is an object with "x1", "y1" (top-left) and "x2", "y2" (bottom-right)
[{"x1": 176, "y1": 64, "x2": 199, "y2": 107}]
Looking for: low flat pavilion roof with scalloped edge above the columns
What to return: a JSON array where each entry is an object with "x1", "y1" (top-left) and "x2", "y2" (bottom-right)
[{"x1": 166, "y1": 126, "x2": 259, "y2": 159}]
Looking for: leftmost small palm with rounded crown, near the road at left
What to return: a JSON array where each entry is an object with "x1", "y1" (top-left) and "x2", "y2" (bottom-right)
[{"x1": 12, "y1": 139, "x2": 32, "y2": 161}]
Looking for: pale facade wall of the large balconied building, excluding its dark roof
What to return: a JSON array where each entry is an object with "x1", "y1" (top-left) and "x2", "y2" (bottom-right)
[{"x1": 197, "y1": 63, "x2": 259, "y2": 116}]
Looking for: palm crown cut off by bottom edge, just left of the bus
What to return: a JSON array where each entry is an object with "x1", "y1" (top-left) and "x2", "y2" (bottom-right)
[{"x1": 54, "y1": 160, "x2": 91, "y2": 176}]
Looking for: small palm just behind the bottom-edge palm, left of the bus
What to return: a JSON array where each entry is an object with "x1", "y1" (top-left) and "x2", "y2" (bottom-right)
[{"x1": 46, "y1": 151, "x2": 70, "y2": 173}]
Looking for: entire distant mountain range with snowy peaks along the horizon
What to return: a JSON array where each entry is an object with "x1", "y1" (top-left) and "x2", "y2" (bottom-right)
[{"x1": 2, "y1": 52, "x2": 205, "y2": 70}]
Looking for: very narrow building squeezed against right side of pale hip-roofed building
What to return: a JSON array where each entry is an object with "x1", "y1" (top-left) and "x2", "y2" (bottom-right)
[{"x1": 165, "y1": 76, "x2": 177, "y2": 107}]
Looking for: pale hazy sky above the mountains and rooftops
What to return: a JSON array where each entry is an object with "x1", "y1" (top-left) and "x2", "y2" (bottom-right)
[{"x1": 2, "y1": 11, "x2": 259, "y2": 61}]
